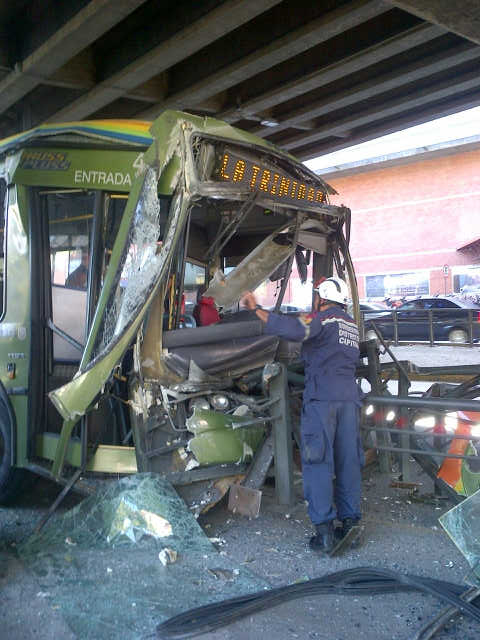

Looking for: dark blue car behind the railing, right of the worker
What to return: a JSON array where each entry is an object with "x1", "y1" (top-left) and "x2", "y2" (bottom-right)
[{"x1": 365, "y1": 296, "x2": 480, "y2": 343}]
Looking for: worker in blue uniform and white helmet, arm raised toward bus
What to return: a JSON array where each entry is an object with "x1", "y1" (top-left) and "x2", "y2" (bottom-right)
[{"x1": 243, "y1": 277, "x2": 363, "y2": 554}]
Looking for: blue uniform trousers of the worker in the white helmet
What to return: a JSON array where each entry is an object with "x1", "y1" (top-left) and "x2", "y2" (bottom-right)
[{"x1": 301, "y1": 400, "x2": 364, "y2": 525}]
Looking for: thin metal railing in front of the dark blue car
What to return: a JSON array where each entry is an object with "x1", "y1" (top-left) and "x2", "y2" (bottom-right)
[{"x1": 361, "y1": 308, "x2": 480, "y2": 346}]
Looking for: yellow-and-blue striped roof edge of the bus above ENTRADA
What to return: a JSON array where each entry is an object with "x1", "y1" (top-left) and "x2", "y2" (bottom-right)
[{"x1": 0, "y1": 120, "x2": 152, "y2": 155}]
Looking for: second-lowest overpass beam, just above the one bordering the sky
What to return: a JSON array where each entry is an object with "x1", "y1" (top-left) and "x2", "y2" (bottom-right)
[{"x1": 279, "y1": 71, "x2": 480, "y2": 151}]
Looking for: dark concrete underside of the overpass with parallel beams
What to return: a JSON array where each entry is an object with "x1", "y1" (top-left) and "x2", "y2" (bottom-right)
[{"x1": 0, "y1": 0, "x2": 480, "y2": 159}]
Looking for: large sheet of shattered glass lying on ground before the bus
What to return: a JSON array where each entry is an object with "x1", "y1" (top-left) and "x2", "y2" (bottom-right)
[{"x1": 19, "y1": 473, "x2": 268, "y2": 640}]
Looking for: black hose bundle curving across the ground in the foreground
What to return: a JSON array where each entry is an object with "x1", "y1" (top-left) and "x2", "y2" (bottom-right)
[{"x1": 157, "y1": 567, "x2": 480, "y2": 639}]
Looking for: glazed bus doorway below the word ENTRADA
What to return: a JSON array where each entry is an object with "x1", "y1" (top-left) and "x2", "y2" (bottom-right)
[{"x1": 39, "y1": 190, "x2": 127, "y2": 431}]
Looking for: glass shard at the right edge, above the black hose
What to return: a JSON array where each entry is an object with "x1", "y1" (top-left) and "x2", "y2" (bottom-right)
[{"x1": 439, "y1": 490, "x2": 480, "y2": 584}]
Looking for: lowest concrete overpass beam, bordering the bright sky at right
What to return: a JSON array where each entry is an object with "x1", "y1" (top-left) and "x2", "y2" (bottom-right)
[{"x1": 292, "y1": 91, "x2": 480, "y2": 161}]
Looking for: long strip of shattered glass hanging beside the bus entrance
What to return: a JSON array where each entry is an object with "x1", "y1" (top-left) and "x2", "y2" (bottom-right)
[{"x1": 91, "y1": 167, "x2": 162, "y2": 359}]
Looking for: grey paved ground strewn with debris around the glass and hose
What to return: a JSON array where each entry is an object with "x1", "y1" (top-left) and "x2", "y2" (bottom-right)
[{"x1": 0, "y1": 347, "x2": 480, "y2": 640}]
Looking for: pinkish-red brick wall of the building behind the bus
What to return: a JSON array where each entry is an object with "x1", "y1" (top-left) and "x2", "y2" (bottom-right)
[{"x1": 325, "y1": 150, "x2": 480, "y2": 296}]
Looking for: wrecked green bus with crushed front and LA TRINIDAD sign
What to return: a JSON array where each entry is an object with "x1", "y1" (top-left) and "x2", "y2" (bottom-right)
[{"x1": 0, "y1": 111, "x2": 358, "y2": 506}]
